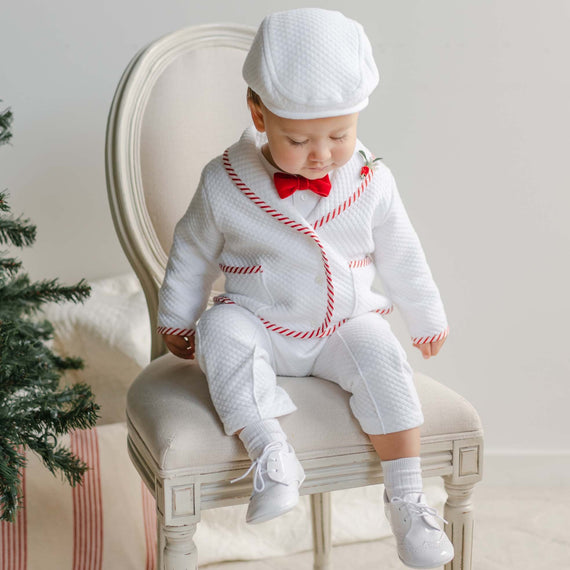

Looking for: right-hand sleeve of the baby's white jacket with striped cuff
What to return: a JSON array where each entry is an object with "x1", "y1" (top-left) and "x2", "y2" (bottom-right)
[{"x1": 373, "y1": 169, "x2": 448, "y2": 344}]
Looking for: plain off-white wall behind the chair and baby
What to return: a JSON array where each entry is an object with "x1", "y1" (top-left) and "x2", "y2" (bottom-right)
[{"x1": 0, "y1": 0, "x2": 570, "y2": 453}]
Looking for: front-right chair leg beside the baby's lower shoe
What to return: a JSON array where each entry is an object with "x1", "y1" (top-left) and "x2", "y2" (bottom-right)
[{"x1": 443, "y1": 477, "x2": 475, "y2": 570}]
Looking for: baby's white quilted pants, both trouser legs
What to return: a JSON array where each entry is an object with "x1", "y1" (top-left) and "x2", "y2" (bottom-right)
[{"x1": 196, "y1": 304, "x2": 423, "y2": 435}]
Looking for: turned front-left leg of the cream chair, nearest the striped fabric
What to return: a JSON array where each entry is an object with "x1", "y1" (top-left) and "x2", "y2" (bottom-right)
[{"x1": 156, "y1": 513, "x2": 198, "y2": 570}]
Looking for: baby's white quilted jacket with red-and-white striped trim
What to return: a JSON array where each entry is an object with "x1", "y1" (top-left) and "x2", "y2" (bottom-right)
[{"x1": 158, "y1": 127, "x2": 448, "y2": 344}]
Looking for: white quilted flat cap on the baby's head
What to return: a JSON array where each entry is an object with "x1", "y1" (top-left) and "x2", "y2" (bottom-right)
[{"x1": 242, "y1": 8, "x2": 378, "y2": 119}]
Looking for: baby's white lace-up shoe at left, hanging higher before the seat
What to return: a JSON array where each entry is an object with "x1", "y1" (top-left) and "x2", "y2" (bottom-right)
[{"x1": 232, "y1": 441, "x2": 305, "y2": 524}]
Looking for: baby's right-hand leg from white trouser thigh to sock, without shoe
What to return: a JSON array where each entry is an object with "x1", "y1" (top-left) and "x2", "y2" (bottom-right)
[{"x1": 313, "y1": 313, "x2": 423, "y2": 497}]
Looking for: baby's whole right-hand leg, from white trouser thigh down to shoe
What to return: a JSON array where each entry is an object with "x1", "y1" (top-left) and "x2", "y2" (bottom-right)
[{"x1": 313, "y1": 313, "x2": 453, "y2": 568}]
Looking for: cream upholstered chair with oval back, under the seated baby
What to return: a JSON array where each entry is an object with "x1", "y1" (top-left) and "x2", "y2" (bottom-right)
[{"x1": 106, "y1": 25, "x2": 483, "y2": 570}]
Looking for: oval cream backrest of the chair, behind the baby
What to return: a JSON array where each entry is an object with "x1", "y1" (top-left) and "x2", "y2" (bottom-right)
[{"x1": 105, "y1": 25, "x2": 255, "y2": 358}]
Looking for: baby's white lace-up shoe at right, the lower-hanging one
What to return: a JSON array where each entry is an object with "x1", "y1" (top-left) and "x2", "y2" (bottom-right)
[{"x1": 384, "y1": 491, "x2": 454, "y2": 568}]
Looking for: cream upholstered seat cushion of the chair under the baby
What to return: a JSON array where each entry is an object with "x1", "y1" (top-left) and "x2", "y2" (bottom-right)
[{"x1": 127, "y1": 354, "x2": 481, "y2": 471}]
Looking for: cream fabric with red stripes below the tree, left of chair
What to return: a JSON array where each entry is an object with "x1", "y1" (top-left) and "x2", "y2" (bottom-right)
[{"x1": 0, "y1": 423, "x2": 156, "y2": 570}]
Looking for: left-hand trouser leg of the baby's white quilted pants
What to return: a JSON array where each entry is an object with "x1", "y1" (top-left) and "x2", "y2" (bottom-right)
[{"x1": 196, "y1": 305, "x2": 297, "y2": 435}]
